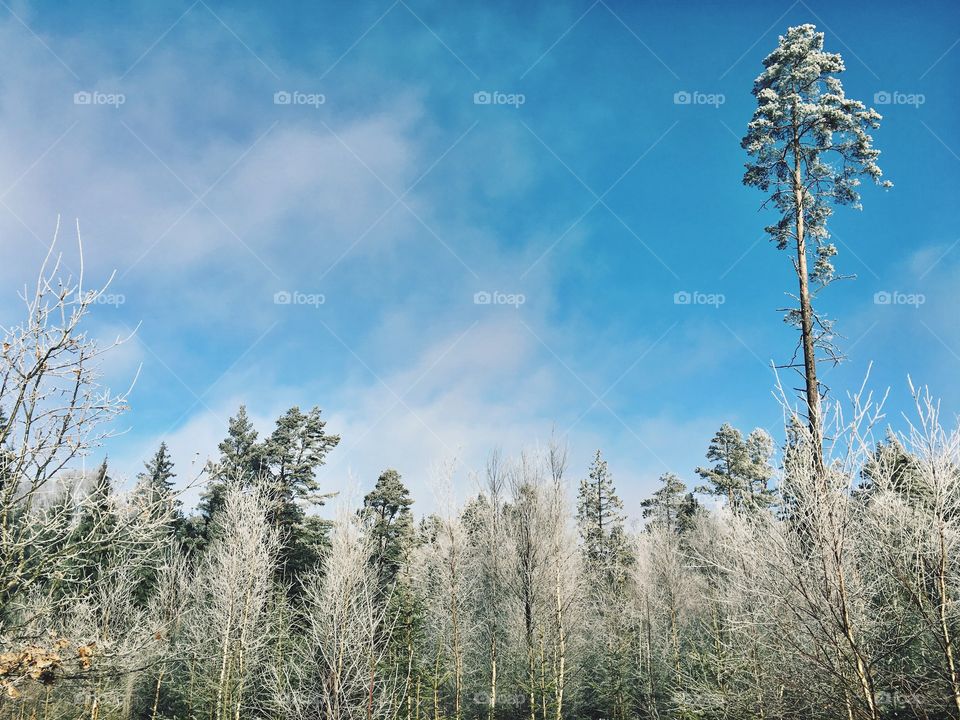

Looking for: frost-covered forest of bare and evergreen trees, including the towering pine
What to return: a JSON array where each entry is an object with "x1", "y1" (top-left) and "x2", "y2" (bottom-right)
[{"x1": 0, "y1": 25, "x2": 960, "y2": 720}]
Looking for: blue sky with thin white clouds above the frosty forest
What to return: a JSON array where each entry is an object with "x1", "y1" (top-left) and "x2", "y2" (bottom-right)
[{"x1": 0, "y1": 0, "x2": 960, "y2": 517}]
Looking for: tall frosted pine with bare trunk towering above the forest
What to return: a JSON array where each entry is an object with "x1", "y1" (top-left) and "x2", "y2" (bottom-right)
[{"x1": 741, "y1": 25, "x2": 891, "y2": 475}]
